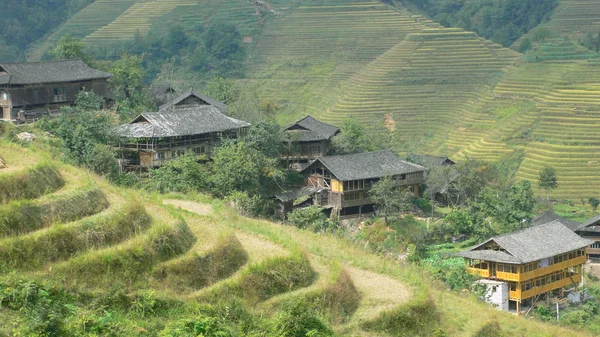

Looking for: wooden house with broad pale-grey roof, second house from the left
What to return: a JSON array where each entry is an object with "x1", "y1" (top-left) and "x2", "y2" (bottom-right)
[{"x1": 116, "y1": 91, "x2": 250, "y2": 169}]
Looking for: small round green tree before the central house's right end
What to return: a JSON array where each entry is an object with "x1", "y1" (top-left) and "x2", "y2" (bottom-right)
[{"x1": 369, "y1": 177, "x2": 414, "y2": 225}]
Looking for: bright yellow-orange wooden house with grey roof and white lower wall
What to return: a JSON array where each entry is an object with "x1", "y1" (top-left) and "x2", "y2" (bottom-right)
[{"x1": 457, "y1": 220, "x2": 592, "y2": 313}]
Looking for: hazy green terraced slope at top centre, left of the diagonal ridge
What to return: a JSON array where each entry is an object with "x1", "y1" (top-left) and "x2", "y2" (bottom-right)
[{"x1": 246, "y1": 1, "x2": 428, "y2": 118}]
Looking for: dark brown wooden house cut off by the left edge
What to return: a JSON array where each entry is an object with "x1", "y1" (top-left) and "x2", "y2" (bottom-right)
[{"x1": 0, "y1": 60, "x2": 111, "y2": 122}]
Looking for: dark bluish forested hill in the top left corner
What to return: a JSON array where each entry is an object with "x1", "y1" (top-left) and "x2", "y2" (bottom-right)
[{"x1": 0, "y1": 0, "x2": 93, "y2": 62}]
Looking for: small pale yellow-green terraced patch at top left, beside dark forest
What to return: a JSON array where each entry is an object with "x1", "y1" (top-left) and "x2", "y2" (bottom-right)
[{"x1": 83, "y1": 0, "x2": 197, "y2": 44}]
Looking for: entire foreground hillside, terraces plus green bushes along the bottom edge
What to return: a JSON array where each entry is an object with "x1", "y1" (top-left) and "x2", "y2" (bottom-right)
[{"x1": 0, "y1": 135, "x2": 586, "y2": 336}]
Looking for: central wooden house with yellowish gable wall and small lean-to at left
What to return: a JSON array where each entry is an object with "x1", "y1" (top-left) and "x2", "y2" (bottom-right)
[{"x1": 275, "y1": 150, "x2": 426, "y2": 219}]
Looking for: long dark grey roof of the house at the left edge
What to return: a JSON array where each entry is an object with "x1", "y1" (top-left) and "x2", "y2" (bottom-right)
[{"x1": 0, "y1": 60, "x2": 111, "y2": 85}]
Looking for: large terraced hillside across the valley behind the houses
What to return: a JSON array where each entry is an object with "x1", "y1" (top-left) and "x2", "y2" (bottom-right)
[{"x1": 32, "y1": 0, "x2": 600, "y2": 200}]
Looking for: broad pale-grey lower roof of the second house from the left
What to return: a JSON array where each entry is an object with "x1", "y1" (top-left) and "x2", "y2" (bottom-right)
[{"x1": 116, "y1": 105, "x2": 250, "y2": 138}]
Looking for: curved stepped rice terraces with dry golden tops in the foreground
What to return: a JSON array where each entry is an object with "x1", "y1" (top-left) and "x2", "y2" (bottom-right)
[{"x1": 0, "y1": 140, "x2": 420, "y2": 336}]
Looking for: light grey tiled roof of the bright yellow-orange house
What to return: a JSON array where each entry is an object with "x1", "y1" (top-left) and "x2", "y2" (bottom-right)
[{"x1": 457, "y1": 220, "x2": 593, "y2": 264}]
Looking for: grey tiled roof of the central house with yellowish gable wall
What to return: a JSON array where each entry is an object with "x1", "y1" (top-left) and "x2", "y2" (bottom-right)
[{"x1": 303, "y1": 150, "x2": 427, "y2": 181}]
